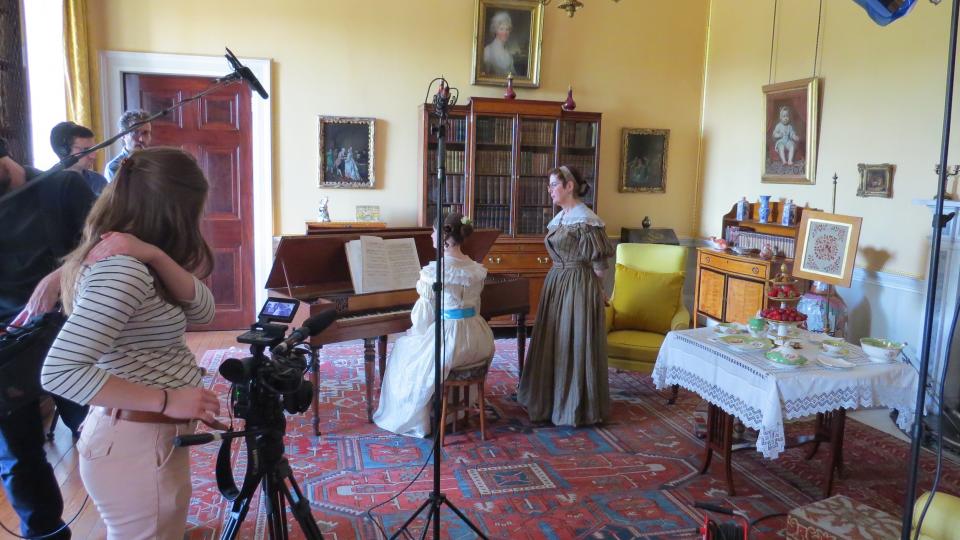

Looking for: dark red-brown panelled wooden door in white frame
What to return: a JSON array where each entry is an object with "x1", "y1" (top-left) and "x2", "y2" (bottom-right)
[{"x1": 124, "y1": 73, "x2": 255, "y2": 330}]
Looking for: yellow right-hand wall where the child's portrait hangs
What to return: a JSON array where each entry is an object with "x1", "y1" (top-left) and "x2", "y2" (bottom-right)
[{"x1": 698, "y1": 0, "x2": 960, "y2": 276}]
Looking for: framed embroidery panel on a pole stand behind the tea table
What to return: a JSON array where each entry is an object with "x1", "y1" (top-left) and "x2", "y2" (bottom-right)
[{"x1": 793, "y1": 210, "x2": 863, "y2": 287}]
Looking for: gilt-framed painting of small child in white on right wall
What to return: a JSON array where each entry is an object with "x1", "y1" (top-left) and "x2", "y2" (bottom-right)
[{"x1": 761, "y1": 77, "x2": 819, "y2": 184}]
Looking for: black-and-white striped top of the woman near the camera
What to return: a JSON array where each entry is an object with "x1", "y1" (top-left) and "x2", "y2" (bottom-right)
[{"x1": 40, "y1": 255, "x2": 214, "y2": 404}]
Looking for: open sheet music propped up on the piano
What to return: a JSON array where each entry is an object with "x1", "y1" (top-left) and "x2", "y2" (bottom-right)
[{"x1": 344, "y1": 236, "x2": 420, "y2": 294}]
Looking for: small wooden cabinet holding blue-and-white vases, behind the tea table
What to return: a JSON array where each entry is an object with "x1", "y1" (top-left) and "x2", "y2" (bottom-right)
[{"x1": 693, "y1": 201, "x2": 807, "y2": 327}]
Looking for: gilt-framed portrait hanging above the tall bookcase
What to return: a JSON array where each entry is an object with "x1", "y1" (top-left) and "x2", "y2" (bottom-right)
[{"x1": 470, "y1": 0, "x2": 543, "y2": 88}]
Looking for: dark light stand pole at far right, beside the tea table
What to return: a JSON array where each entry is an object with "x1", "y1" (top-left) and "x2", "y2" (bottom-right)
[{"x1": 900, "y1": 0, "x2": 960, "y2": 540}]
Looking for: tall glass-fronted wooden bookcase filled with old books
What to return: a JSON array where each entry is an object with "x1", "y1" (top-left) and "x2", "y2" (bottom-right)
[{"x1": 419, "y1": 97, "x2": 601, "y2": 325}]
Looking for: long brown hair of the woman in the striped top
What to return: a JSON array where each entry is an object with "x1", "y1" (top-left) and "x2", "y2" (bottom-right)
[{"x1": 60, "y1": 147, "x2": 213, "y2": 313}]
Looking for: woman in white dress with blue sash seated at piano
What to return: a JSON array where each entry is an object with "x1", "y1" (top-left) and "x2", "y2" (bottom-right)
[{"x1": 373, "y1": 212, "x2": 494, "y2": 437}]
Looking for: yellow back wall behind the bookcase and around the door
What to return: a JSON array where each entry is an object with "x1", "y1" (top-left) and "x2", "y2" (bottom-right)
[{"x1": 88, "y1": 0, "x2": 708, "y2": 235}]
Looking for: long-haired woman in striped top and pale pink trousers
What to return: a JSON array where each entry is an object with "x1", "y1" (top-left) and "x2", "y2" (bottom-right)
[{"x1": 42, "y1": 148, "x2": 219, "y2": 540}]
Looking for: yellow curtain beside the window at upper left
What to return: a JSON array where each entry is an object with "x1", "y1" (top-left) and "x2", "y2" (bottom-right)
[{"x1": 63, "y1": 0, "x2": 93, "y2": 129}]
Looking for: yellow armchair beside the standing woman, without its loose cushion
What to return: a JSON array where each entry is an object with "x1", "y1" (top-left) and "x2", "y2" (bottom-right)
[{"x1": 606, "y1": 244, "x2": 690, "y2": 373}]
